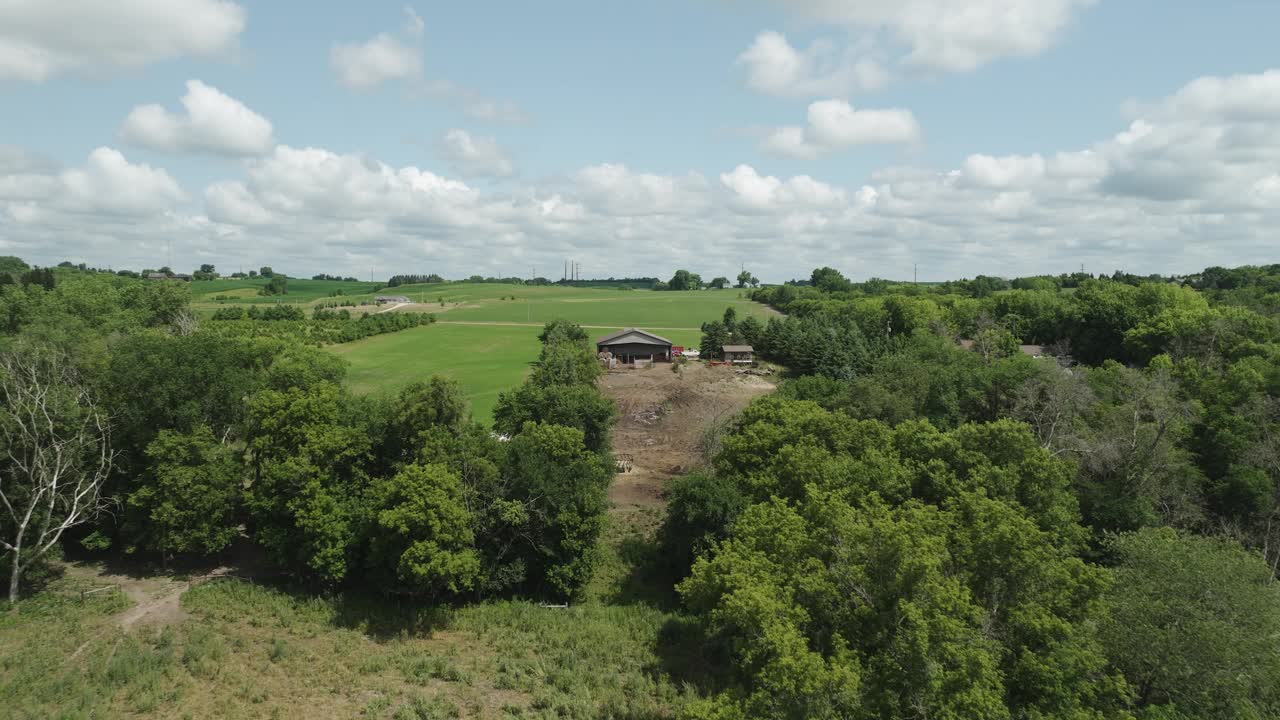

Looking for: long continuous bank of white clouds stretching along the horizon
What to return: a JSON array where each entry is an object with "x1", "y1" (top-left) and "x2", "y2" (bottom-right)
[{"x1": 10, "y1": 73, "x2": 1280, "y2": 281}]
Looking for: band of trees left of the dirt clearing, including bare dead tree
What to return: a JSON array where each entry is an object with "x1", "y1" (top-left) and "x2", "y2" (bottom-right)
[{"x1": 0, "y1": 262, "x2": 614, "y2": 600}]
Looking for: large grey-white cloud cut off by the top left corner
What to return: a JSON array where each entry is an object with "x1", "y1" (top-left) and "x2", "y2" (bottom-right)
[{"x1": 0, "y1": 0, "x2": 244, "y2": 82}]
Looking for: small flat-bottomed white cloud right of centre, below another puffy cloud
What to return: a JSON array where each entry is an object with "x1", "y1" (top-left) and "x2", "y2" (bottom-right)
[{"x1": 763, "y1": 100, "x2": 922, "y2": 159}]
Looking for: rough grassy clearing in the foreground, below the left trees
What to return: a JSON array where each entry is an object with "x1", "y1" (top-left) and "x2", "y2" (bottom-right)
[{"x1": 0, "y1": 516, "x2": 705, "y2": 720}]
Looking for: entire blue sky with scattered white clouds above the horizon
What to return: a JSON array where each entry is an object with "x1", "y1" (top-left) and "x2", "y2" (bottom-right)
[{"x1": 0, "y1": 0, "x2": 1280, "y2": 282}]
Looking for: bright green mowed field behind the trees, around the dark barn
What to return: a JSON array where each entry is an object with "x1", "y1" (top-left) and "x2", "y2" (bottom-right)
[{"x1": 329, "y1": 283, "x2": 771, "y2": 424}]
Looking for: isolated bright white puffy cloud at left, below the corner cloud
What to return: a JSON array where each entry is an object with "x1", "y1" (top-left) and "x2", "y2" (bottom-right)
[{"x1": 120, "y1": 79, "x2": 275, "y2": 155}]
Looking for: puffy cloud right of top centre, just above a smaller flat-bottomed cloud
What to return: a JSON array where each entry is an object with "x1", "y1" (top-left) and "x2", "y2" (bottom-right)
[{"x1": 737, "y1": 31, "x2": 888, "y2": 97}]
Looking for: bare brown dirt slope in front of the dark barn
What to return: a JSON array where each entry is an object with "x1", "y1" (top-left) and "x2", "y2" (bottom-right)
[{"x1": 600, "y1": 363, "x2": 773, "y2": 511}]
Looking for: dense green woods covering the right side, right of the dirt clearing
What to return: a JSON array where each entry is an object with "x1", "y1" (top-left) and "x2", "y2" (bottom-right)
[{"x1": 650, "y1": 260, "x2": 1280, "y2": 720}]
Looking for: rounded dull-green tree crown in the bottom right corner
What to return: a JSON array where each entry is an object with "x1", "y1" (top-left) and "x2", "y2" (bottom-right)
[{"x1": 1102, "y1": 528, "x2": 1280, "y2": 717}]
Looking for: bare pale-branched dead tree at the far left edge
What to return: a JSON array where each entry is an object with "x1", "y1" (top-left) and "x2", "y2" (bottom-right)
[{"x1": 0, "y1": 347, "x2": 115, "y2": 602}]
